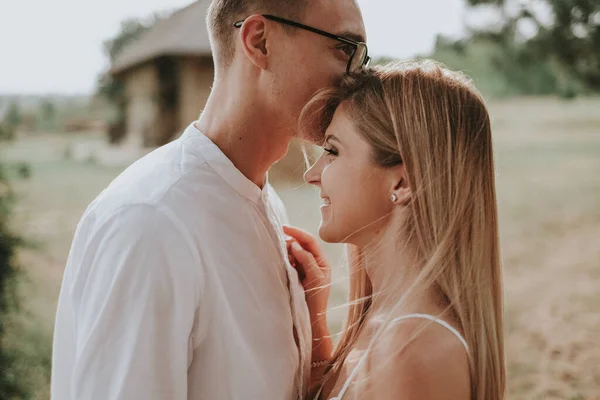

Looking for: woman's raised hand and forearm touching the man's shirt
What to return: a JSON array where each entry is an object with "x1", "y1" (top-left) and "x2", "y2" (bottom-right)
[{"x1": 283, "y1": 226, "x2": 333, "y2": 361}]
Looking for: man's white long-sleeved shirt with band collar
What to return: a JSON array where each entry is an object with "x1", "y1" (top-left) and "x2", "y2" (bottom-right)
[{"x1": 52, "y1": 125, "x2": 311, "y2": 400}]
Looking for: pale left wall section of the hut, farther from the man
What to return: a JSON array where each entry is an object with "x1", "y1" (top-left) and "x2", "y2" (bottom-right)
[{"x1": 123, "y1": 63, "x2": 158, "y2": 146}]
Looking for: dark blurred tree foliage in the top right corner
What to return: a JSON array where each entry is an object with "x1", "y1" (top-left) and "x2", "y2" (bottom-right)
[{"x1": 467, "y1": 0, "x2": 600, "y2": 91}]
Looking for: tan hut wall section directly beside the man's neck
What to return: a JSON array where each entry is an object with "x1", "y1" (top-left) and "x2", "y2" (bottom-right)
[{"x1": 178, "y1": 57, "x2": 214, "y2": 131}]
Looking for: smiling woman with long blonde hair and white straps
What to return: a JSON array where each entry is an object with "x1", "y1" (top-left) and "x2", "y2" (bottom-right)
[{"x1": 285, "y1": 61, "x2": 505, "y2": 400}]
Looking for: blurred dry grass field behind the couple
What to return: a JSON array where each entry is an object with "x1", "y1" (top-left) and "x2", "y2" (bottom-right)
[{"x1": 0, "y1": 99, "x2": 600, "y2": 400}]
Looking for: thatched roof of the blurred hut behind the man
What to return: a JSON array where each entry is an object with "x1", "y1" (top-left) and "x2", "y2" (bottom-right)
[{"x1": 111, "y1": 0, "x2": 212, "y2": 74}]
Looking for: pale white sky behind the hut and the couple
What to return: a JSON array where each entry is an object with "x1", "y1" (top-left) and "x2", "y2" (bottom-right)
[{"x1": 0, "y1": 0, "x2": 464, "y2": 95}]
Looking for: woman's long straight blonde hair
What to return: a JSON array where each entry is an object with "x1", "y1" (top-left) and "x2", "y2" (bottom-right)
[{"x1": 302, "y1": 61, "x2": 506, "y2": 400}]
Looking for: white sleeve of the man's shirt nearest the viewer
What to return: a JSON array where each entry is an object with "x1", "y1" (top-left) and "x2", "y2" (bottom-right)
[{"x1": 71, "y1": 205, "x2": 201, "y2": 400}]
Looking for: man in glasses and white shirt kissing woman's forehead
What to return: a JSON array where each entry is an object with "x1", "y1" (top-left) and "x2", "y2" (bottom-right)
[{"x1": 52, "y1": 0, "x2": 368, "y2": 400}]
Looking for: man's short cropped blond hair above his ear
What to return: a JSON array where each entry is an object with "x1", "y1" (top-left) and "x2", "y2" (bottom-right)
[{"x1": 206, "y1": 0, "x2": 309, "y2": 68}]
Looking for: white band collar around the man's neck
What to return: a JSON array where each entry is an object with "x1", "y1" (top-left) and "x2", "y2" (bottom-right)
[{"x1": 180, "y1": 122, "x2": 268, "y2": 203}]
